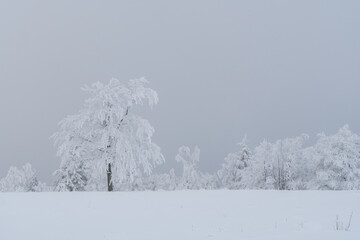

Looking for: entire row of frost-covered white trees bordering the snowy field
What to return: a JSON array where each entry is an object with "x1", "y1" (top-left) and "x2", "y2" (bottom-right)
[{"x1": 0, "y1": 78, "x2": 360, "y2": 191}]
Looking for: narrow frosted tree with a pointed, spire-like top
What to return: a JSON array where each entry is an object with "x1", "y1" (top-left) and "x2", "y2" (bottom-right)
[{"x1": 218, "y1": 136, "x2": 251, "y2": 189}]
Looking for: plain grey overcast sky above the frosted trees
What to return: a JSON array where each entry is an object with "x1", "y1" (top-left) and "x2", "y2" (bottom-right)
[{"x1": 0, "y1": 0, "x2": 360, "y2": 181}]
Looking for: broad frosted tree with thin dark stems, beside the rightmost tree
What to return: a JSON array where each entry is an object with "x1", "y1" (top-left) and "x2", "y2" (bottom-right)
[{"x1": 244, "y1": 134, "x2": 308, "y2": 190}]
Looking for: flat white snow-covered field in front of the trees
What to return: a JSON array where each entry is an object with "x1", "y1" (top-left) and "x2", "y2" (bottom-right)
[{"x1": 0, "y1": 190, "x2": 360, "y2": 240}]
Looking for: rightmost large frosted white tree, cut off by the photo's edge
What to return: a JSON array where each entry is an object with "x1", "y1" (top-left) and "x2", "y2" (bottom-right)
[{"x1": 311, "y1": 125, "x2": 360, "y2": 190}]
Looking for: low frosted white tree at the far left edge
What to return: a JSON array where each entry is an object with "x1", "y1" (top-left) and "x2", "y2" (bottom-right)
[{"x1": 0, "y1": 163, "x2": 44, "y2": 192}]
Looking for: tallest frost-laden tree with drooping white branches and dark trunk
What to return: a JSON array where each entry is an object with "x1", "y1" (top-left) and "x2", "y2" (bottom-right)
[{"x1": 54, "y1": 78, "x2": 164, "y2": 191}]
